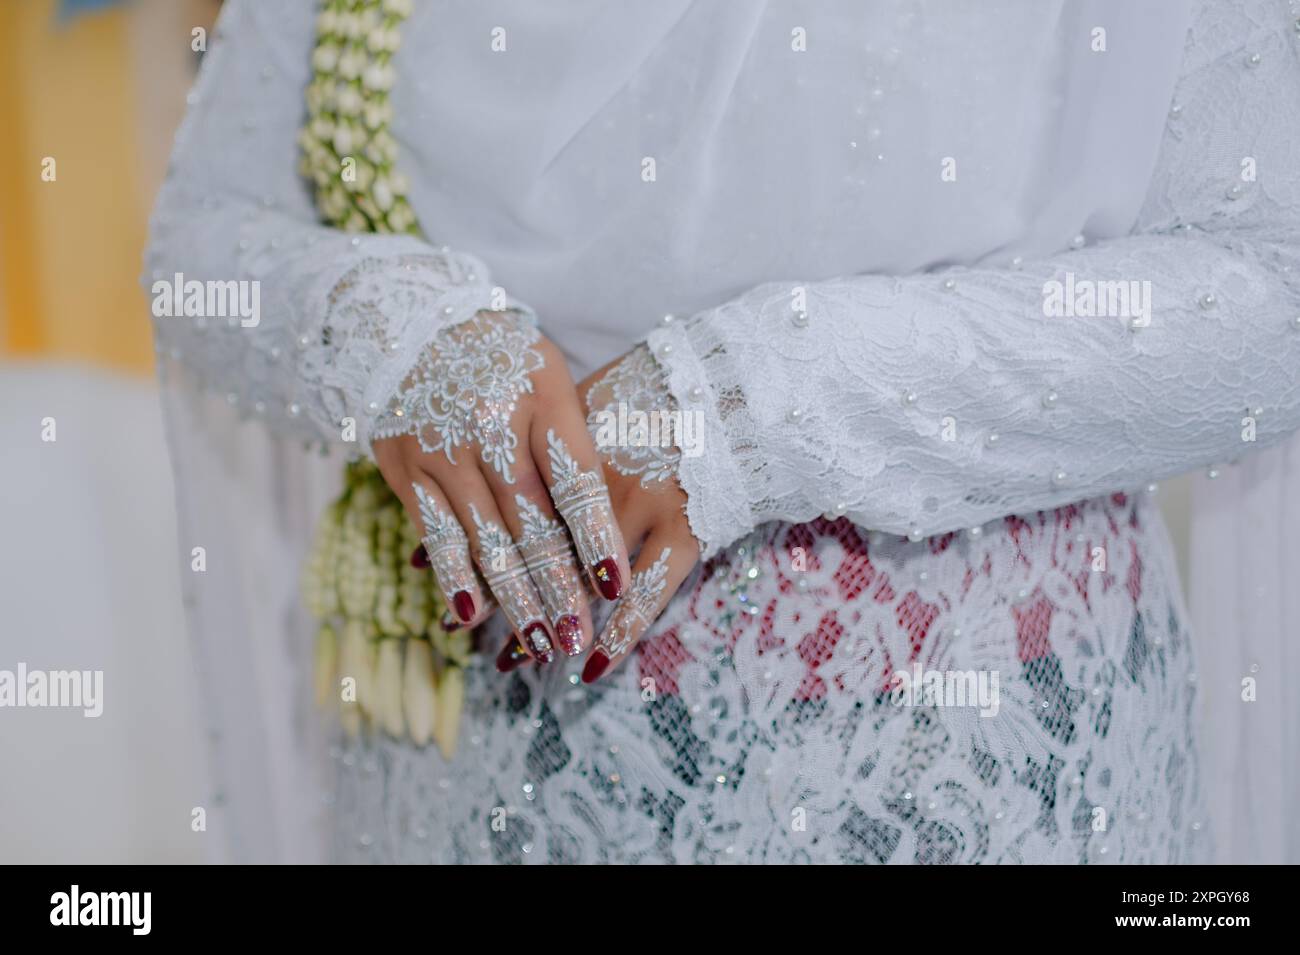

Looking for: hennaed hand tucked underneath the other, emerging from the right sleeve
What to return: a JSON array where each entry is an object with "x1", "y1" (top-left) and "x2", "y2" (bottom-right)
[{"x1": 497, "y1": 344, "x2": 699, "y2": 683}]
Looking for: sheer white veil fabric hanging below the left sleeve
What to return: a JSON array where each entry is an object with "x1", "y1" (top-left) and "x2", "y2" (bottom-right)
[{"x1": 163, "y1": 384, "x2": 342, "y2": 864}]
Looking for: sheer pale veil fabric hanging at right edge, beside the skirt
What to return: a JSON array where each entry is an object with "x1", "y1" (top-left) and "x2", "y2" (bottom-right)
[{"x1": 1187, "y1": 435, "x2": 1300, "y2": 865}]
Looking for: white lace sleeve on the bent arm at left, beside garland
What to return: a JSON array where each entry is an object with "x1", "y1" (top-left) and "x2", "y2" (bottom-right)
[{"x1": 144, "y1": 1, "x2": 527, "y2": 447}]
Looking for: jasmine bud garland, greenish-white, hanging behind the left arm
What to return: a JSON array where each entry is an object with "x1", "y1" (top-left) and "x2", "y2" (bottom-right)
[{"x1": 299, "y1": 0, "x2": 471, "y2": 759}]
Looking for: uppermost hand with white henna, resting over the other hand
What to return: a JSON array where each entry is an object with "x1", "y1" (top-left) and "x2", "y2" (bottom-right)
[{"x1": 372, "y1": 312, "x2": 628, "y2": 663}]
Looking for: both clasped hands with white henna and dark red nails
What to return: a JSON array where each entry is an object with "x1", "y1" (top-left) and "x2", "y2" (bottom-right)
[{"x1": 372, "y1": 312, "x2": 699, "y2": 683}]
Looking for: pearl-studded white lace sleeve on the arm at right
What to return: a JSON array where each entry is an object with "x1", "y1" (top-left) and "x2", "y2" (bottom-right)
[{"x1": 647, "y1": 0, "x2": 1300, "y2": 554}]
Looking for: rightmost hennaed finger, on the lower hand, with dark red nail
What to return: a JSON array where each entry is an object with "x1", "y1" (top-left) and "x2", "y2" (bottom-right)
[{"x1": 582, "y1": 525, "x2": 699, "y2": 683}]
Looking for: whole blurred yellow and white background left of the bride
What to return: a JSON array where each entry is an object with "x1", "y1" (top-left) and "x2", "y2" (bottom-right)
[{"x1": 0, "y1": 0, "x2": 217, "y2": 863}]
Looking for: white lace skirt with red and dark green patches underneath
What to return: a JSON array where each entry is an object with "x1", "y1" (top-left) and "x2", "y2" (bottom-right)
[{"x1": 325, "y1": 495, "x2": 1210, "y2": 864}]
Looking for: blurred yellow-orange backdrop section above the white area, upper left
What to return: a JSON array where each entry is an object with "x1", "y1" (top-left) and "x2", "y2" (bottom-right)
[{"x1": 0, "y1": 0, "x2": 217, "y2": 376}]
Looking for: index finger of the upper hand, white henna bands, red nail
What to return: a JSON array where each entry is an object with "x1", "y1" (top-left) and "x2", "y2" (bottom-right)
[{"x1": 533, "y1": 423, "x2": 629, "y2": 600}]
